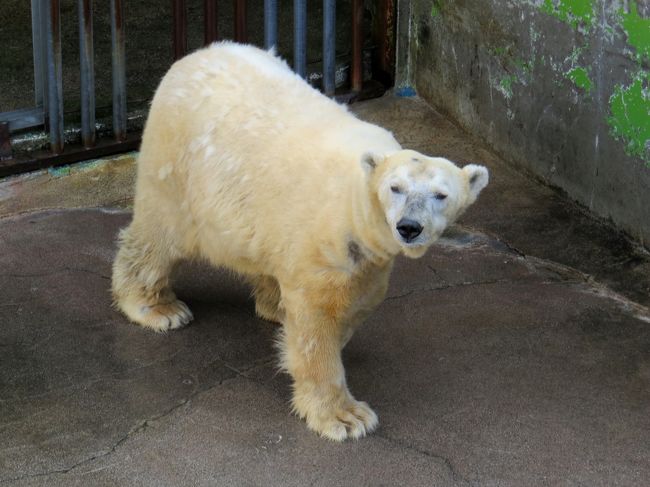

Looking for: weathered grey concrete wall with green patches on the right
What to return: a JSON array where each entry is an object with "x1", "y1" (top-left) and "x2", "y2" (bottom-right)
[{"x1": 397, "y1": 0, "x2": 650, "y2": 246}]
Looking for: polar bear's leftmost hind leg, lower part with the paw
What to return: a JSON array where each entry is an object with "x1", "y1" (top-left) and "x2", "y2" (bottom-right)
[{"x1": 112, "y1": 223, "x2": 193, "y2": 332}]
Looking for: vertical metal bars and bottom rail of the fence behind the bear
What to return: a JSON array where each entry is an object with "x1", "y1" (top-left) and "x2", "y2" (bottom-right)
[{"x1": 0, "y1": 0, "x2": 394, "y2": 176}]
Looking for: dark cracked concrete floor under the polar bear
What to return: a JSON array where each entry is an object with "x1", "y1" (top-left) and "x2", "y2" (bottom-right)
[{"x1": 0, "y1": 97, "x2": 650, "y2": 486}]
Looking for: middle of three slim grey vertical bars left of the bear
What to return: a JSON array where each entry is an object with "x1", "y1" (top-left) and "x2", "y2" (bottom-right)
[{"x1": 78, "y1": 0, "x2": 95, "y2": 149}]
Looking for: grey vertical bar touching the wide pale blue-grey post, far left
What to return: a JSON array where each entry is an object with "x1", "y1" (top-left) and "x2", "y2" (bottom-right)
[{"x1": 45, "y1": 0, "x2": 64, "y2": 154}]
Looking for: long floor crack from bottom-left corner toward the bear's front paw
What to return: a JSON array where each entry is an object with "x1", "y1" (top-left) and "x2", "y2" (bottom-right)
[{"x1": 0, "y1": 357, "x2": 275, "y2": 484}]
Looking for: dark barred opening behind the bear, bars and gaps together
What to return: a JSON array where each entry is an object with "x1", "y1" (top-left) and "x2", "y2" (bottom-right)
[{"x1": 0, "y1": 0, "x2": 395, "y2": 176}]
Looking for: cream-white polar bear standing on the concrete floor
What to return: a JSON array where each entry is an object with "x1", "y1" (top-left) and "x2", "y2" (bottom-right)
[{"x1": 112, "y1": 43, "x2": 488, "y2": 441}]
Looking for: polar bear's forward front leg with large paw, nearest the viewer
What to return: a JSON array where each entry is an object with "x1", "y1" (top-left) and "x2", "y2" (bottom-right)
[{"x1": 281, "y1": 289, "x2": 378, "y2": 441}]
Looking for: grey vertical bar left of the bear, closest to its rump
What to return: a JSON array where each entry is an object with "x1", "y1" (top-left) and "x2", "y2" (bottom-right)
[{"x1": 111, "y1": 0, "x2": 126, "y2": 141}]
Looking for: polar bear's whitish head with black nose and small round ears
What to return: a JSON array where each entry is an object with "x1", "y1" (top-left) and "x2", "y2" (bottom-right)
[{"x1": 362, "y1": 150, "x2": 489, "y2": 258}]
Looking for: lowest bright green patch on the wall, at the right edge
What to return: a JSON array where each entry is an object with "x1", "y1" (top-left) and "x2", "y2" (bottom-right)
[{"x1": 607, "y1": 71, "x2": 650, "y2": 167}]
